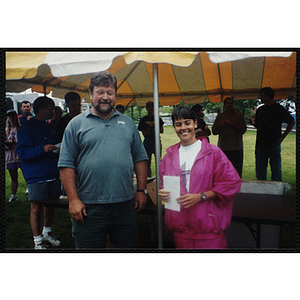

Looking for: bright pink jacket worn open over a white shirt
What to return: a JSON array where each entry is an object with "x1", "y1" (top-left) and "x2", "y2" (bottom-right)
[{"x1": 160, "y1": 137, "x2": 242, "y2": 239}]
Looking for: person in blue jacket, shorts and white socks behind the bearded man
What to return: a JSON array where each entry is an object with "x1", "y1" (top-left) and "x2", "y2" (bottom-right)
[{"x1": 16, "y1": 97, "x2": 61, "y2": 249}]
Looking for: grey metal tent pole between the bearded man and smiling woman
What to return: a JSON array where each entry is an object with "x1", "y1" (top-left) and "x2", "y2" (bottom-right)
[{"x1": 153, "y1": 63, "x2": 163, "y2": 249}]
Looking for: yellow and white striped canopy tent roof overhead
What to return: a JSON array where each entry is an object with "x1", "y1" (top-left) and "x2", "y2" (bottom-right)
[{"x1": 6, "y1": 51, "x2": 296, "y2": 106}]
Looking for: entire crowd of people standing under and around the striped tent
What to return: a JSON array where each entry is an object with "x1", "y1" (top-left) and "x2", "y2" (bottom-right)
[{"x1": 5, "y1": 71, "x2": 295, "y2": 250}]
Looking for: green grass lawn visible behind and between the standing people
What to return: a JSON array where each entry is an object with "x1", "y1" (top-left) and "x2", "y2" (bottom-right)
[{"x1": 5, "y1": 126, "x2": 296, "y2": 251}]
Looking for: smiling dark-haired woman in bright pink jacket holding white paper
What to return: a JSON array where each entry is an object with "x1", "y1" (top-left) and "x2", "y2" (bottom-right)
[{"x1": 158, "y1": 107, "x2": 242, "y2": 249}]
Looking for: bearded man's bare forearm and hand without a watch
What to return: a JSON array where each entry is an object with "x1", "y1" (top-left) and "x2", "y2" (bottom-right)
[{"x1": 59, "y1": 168, "x2": 87, "y2": 223}]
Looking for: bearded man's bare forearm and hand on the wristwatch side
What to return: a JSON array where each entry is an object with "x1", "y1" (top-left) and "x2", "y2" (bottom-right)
[{"x1": 134, "y1": 160, "x2": 147, "y2": 211}]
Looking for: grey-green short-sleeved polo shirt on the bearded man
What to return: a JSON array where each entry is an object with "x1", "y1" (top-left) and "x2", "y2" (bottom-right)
[{"x1": 58, "y1": 109, "x2": 148, "y2": 204}]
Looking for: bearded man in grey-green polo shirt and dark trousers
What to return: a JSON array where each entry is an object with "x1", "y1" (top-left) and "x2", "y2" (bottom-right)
[{"x1": 58, "y1": 72, "x2": 147, "y2": 248}]
